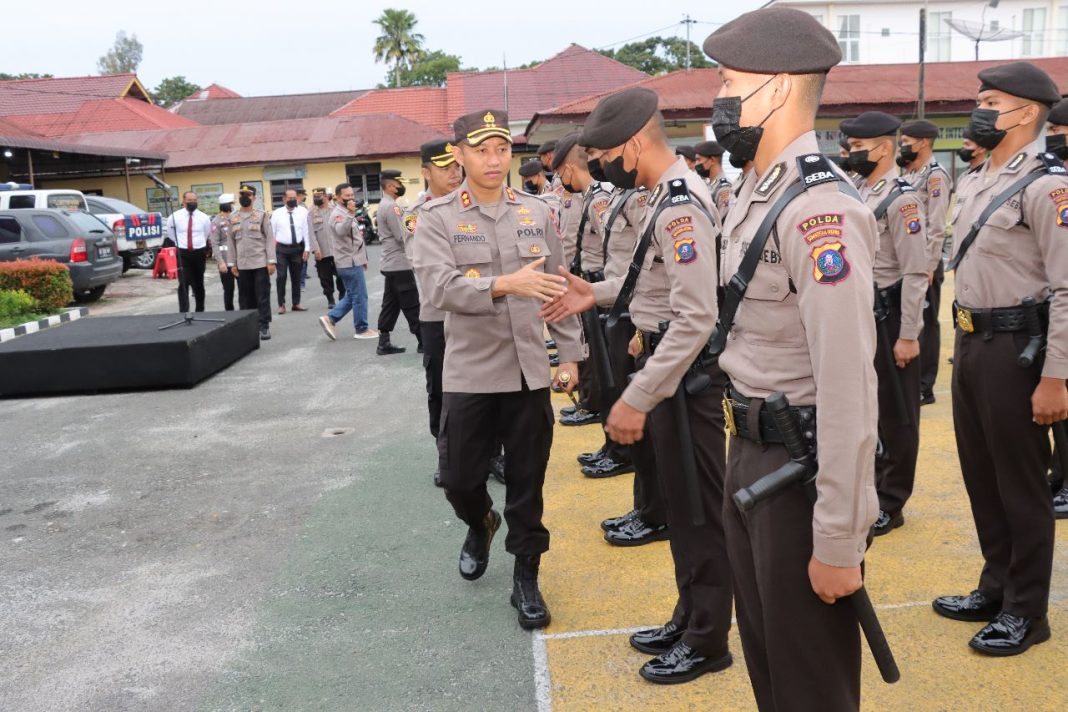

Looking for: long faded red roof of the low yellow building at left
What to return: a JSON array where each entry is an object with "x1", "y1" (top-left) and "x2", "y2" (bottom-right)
[{"x1": 62, "y1": 114, "x2": 444, "y2": 169}]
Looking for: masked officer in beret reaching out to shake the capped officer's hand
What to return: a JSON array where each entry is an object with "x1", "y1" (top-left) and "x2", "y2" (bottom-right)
[{"x1": 543, "y1": 88, "x2": 733, "y2": 683}]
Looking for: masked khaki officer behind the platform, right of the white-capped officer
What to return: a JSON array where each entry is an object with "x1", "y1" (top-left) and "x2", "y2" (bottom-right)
[{"x1": 226, "y1": 185, "x2": 277, "y2": 342}]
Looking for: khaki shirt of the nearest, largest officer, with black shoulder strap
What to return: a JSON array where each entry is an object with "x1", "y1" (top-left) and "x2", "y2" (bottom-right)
[{"x1": 720, "y1": 131, "x2": 879, "y2": 567}]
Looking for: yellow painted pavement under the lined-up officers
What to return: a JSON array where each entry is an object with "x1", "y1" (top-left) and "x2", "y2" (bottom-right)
[{"x1": 535, "y1": 279, "x2": 1068, "y2": 712}]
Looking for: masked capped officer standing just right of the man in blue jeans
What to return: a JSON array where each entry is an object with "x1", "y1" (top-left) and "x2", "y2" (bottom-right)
[{"x1": 376, "y1": 171, "x2": 423, "y2": 355}]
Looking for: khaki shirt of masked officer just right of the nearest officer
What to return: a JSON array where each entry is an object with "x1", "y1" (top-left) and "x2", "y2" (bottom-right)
[{"x1": 860, "y1": 169, "x2": 927, "y2": 341}]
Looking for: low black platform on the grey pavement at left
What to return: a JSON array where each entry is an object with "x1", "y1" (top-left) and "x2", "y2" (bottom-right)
[{"x1": 0, "y1": 311, "x2": 260, "y2": 397}]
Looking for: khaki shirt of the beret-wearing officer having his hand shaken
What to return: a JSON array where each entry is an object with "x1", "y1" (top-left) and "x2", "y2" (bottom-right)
[{"x1": 593, "y1": 156, "x2": 720, "y2": 413}]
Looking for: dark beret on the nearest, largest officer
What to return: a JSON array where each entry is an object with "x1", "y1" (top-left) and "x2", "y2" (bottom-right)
[{"x1": 704, "y1": 6, "x2": 842, "y2": 74}]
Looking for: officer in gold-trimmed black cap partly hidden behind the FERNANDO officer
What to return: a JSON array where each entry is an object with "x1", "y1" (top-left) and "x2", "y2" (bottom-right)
[{"x1": 404, "y1": 141, "x2": 461, "y2": 487}]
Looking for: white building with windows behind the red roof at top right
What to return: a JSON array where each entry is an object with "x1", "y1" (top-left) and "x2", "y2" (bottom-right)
[{"x1": 768, "y1": 0, "x2": 1068, "y2": 64}]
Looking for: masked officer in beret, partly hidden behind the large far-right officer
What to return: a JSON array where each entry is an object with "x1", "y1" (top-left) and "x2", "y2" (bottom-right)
[{"x1": 897, "y1": 120, "x2": 953, "y2": 406}]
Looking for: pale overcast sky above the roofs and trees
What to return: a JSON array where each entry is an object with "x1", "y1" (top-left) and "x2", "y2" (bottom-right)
[{"x1": 0, "y1": 0, "x2": 765, "y2": 96}]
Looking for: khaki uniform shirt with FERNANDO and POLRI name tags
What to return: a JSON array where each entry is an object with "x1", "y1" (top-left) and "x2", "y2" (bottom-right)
[{"x1": 414, "y1": 181, "x2": 585, "y2": 393}]
